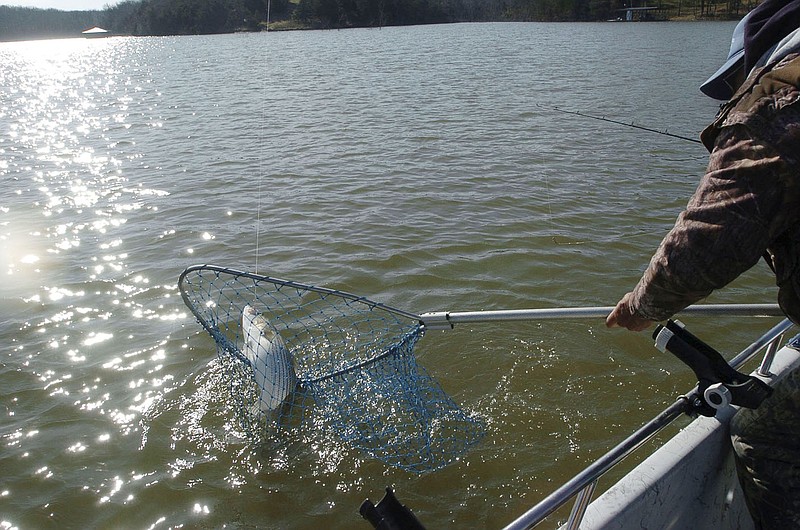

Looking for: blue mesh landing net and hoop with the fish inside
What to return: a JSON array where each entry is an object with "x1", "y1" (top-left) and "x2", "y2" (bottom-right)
[{"x1": 178, "y1": 265, "x2": 483, "y2": 473}]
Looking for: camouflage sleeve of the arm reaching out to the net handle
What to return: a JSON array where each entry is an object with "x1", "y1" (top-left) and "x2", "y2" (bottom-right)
[{"x1": 631, "y1": 125, "x2": 796, "y2": 321}]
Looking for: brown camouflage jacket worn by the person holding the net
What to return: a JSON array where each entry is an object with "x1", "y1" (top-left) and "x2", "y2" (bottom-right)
[{"x1": 631, "y1": 54, "x2": 800, "y2": 323}]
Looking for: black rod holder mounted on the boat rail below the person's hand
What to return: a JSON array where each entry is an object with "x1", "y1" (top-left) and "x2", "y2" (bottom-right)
[{"x1": 653, "y1": 320, "x2": 772, "y2": 416}]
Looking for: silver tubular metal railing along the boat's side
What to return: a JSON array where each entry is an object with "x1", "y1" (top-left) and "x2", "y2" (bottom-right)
[{"x1": 506, "y1": 319, "x2": 793, "y2": 530}]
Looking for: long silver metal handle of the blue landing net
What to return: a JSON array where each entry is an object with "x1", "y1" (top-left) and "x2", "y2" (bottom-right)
[{"x1": 419, "y1": 304, "x2": 785, "y2": 329}]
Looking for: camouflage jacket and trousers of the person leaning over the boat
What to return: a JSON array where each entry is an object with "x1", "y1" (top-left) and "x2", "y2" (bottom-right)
[{"x1": 630, "y1": 53, "x2": 800, "y2": 529}]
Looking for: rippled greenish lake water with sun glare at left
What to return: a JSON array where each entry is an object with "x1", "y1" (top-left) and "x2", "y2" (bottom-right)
[{"x1": 0, "y1": 23, "x2": 775, "y2": 528}]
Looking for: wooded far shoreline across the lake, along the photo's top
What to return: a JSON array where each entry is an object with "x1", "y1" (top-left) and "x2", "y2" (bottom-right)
[{"x1": 0, "y1": 0, "x2": 758, "y2": 41}]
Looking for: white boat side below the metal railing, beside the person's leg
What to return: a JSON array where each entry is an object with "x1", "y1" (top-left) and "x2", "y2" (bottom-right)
[{"x1": 562, "y1": 335, "x2": 800, "y2": 530}]
